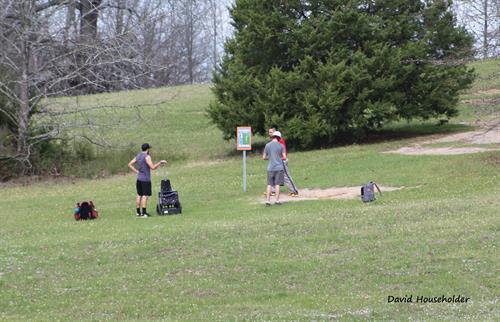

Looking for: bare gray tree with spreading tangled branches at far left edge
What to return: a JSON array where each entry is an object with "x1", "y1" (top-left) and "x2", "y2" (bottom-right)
[{"x1": 0, "y1": 0, "x2": 161, "y2": 170}]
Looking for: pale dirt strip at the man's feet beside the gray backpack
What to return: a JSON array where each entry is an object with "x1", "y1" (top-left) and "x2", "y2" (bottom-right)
[{"x1": 262, "y1": 186, "x2": 405, "y2": 203}]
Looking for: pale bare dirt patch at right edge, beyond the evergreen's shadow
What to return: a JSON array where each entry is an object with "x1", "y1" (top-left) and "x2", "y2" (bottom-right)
[{"x1": 384, "y1": 119, "x2": 500, "y2": 155}]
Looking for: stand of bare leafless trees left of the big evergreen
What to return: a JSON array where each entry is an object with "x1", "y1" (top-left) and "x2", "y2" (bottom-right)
[{"x1": 0, "y1": 0, "x2": 230, "y2": 174}]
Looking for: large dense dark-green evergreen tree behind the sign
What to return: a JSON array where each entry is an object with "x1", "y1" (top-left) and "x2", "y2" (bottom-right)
[{"x1": 208, "y1": 0, "x2": 474, "y2": 148}]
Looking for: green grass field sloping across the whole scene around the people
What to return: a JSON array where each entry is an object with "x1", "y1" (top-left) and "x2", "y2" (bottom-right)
[{"x1": 0, "y1": 60, "x2": 500, "y2": 321}]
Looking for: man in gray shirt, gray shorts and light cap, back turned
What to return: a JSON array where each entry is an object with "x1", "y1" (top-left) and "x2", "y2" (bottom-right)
[{"x1": 262, "y1": 131, "x2": 286, "y2": 206}]
